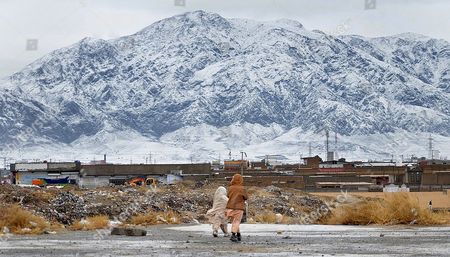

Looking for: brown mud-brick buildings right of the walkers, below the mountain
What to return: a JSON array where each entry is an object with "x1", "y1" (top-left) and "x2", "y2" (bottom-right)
[{"x1": 223, "y1": 156, "x2": 450, "y2": 191}]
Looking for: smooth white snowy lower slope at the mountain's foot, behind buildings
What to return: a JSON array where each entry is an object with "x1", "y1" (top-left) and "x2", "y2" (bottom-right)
[{"x1": 4, "y1": 124, "x2": 450, "y2": 163}]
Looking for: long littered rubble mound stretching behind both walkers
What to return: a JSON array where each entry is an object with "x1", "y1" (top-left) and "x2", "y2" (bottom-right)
[{"x1": 0, "y1": 183, "x2": 328, "y2": 225}]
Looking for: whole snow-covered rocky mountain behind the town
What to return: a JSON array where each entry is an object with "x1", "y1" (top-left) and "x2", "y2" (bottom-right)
[{"x1": 0, "y1": 11, "x2": 450, "y2": 160}]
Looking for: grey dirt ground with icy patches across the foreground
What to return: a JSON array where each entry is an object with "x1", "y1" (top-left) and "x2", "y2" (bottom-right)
[{"x1": 0, "y1": 224, "x2": 450, "y2": 257}]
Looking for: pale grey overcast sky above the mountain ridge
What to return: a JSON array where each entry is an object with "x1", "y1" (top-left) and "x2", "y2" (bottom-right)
[{"x1": 0, "y1": 0, "x2": 450, "y2": 77}]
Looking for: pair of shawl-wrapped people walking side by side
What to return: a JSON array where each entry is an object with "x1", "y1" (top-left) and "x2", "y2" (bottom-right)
[{"x1": 206, "y1": 174, "x2": 248, "y2": 242}]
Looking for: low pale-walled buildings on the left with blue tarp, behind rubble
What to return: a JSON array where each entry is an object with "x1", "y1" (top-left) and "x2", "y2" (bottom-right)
[{"x1": 5, "y1": 161, "x2": 211, "y2": 188}]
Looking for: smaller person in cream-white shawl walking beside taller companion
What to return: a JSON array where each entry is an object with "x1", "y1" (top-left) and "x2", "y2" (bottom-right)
[{"x1": 206, "y1": 186, "x2": 229, "y2": 237}]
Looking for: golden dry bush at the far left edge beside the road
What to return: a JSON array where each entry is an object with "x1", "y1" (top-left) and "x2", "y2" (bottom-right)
[{"x1": 0, "y1": 205, "x2": 50, "y2": 234}]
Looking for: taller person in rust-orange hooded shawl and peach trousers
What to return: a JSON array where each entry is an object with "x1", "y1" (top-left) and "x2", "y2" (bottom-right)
[{"x1": 227, "y1": 174, "x2": 248, "y2": 242}]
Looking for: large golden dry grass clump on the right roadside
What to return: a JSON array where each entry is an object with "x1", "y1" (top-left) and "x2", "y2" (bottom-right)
[{"x1": 323, "y1": 193, "x2": 448, "y2": 225}]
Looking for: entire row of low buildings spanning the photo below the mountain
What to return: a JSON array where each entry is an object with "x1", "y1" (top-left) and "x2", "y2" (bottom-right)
[{"x1": 1, "y1": 156, "x2": 450, "y2": 191}]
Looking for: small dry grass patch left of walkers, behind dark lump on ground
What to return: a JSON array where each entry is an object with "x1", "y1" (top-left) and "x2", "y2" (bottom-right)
[{"x1": 130, "y1": 211, "x2": 181, "y2": 226}]
